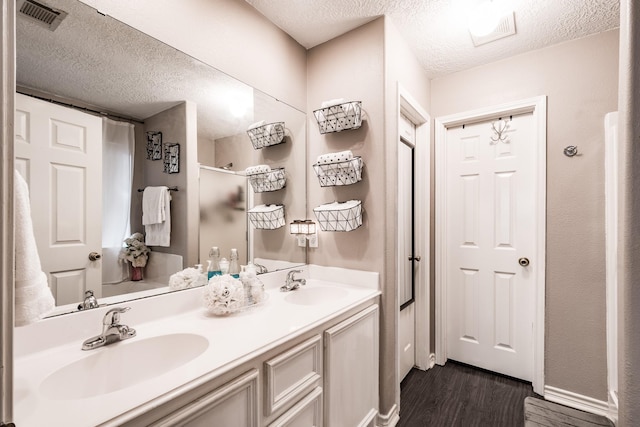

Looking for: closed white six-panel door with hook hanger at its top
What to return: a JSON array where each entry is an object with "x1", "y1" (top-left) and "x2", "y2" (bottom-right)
[{"x1": 445, "y1": 113, "x2": 537, "y2": 381}]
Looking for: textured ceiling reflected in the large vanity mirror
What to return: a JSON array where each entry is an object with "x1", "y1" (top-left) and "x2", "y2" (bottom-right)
[{"x1": 16, "y1": 0, "x2": 255, "y2": 139}]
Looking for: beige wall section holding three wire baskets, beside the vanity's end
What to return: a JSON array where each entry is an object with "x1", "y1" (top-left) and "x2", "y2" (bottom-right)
[{"x1": 307, "y1": 19, "x2": 388, "y2": 414}]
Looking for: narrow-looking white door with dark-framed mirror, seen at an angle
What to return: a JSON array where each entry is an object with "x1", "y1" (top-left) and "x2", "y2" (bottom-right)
[{"x1": 398, "y1": 115, "x2": 419, "y2": 380}]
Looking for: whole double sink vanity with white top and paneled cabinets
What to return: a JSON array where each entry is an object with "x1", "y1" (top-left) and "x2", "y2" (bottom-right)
[{"x1": 14, "y1": 265, "x2": 380, "y2": 427}]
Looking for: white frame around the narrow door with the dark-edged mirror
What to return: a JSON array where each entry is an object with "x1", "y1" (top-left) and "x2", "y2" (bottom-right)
[{"x1": 396, "y1": 83, "x2": 433, "y2": 370}]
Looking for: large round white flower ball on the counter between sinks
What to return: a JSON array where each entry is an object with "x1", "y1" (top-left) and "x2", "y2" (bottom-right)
[{"x1": 202, "y1": 274, "x2": 245, "y2": 315}]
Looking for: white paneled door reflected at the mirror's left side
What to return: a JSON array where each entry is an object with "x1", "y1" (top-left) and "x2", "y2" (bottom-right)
[{"x1": 15, "y1": 94, "x2": 102, "y2": 305}]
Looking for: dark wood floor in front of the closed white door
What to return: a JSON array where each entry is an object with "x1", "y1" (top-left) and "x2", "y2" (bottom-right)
[{"x1": 398, "y1": 361, "x2": 539, "y2": 427}]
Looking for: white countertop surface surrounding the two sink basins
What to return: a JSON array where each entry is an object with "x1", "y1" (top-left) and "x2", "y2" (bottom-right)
[{"x1": 14, "y1": 266, "x2": 380, "y2": 427}]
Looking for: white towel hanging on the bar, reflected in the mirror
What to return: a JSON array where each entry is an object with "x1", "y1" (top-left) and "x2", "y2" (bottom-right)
[{"x1": 142, "y1": 187, "x2": 171, "y2": 247}]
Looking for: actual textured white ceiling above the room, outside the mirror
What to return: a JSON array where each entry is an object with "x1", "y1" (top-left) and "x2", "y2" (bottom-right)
[{"x1": 246, "y1": 0, "x2": 620, "y2": 78}]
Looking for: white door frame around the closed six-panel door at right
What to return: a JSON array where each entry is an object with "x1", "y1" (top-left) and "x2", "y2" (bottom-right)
[{"x1": 434, "y1": 96, "x2": 547, "y2": 395}]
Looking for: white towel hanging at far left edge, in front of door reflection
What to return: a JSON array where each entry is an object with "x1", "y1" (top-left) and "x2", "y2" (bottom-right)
[{"x1": 13, "y1": 171, "x2": 55, "y2": 326}]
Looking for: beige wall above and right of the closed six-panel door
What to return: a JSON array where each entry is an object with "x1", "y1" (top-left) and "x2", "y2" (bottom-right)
[{"x1": 431, "y1": 31, "x2": 618, "y2": 401}]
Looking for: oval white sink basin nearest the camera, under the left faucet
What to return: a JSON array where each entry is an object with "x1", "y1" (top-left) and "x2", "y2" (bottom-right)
[{"x1": 40, "y1": 334, "x2": 209, "y2": 400}]
